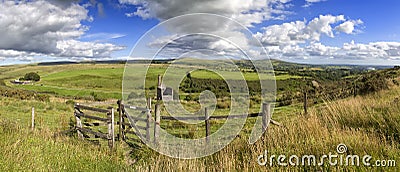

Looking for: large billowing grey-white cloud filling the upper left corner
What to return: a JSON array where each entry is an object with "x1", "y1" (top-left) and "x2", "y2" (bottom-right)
[{"x1": 0, "y1": 1, "x2": 88, "y2": 53}]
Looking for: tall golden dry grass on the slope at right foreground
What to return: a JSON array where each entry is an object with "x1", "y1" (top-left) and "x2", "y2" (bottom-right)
[{"x1": 134, "y1": 88, "x2": 400, "y2": 171}]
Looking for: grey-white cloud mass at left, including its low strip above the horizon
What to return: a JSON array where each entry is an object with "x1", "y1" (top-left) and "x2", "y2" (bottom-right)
[{"x1": 0, "y1": 0, "x2": 125, "y2": 61}]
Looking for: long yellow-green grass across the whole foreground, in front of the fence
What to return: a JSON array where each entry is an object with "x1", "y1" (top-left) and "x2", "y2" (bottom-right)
[{"x1": 0, "y1": 87, "x2": 400, "y2": 171}]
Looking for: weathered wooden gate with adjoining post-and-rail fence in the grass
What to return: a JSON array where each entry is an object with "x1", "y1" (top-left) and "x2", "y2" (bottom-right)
[{"x1": 74, "y1": 74, "x2": 282, "y2": 149}]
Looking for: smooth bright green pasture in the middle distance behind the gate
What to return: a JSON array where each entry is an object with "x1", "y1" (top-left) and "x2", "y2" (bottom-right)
[{"x1": 0, "y1": 64, "x2": 301, "y2": 100}]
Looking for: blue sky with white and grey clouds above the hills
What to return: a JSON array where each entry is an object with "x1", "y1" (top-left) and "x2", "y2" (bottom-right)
[{"x1": 0, "y1": 0, "x2": 400, "y2": 65}]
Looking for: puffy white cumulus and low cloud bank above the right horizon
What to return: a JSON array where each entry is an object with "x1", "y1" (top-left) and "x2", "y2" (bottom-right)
[{"x1": 254, "y1": 15, "x2": 400, "y2": 60}]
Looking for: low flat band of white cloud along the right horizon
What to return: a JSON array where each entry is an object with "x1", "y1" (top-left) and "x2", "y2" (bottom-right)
[{"x1": 266, "y1": 41, "x2": 400, "y2": 63}]
